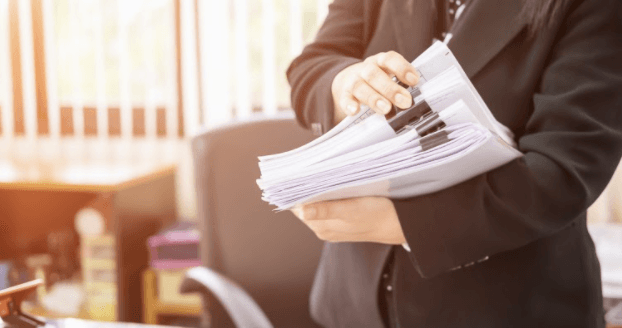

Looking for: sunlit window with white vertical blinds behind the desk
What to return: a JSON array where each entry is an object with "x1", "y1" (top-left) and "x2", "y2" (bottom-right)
[{"x1": 0, "y1": 0, "x2": 328, "y2": 217}]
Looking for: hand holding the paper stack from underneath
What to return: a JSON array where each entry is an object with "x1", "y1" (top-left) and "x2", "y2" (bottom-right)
[{"x1": 292, "y1": 197, "x2": 406, "y2": 245}]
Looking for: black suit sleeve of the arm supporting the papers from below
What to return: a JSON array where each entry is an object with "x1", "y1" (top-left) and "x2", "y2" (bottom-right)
[{"x1": 393, "y1": 1, "x2": 622, "y2": 277}]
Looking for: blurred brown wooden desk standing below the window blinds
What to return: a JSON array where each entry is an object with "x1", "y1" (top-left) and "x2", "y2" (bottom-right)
[{"x1": 0, "y1": 139, "x2": 178, "y2": 322}]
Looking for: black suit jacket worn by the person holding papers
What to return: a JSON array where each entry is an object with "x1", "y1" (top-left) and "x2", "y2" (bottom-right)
[{"x1": 288, "y1": 0, "x2": 622, "y2": 327}]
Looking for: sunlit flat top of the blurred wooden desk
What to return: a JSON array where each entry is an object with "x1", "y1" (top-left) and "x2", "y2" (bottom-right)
[{"x1": 0, "y1": 138, "x2": 182, "y2": 192}]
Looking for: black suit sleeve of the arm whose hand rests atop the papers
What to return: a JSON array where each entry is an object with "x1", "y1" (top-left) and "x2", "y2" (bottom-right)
[{"x1": 287, "y1": 0, "x2": 378, "y2": 132}]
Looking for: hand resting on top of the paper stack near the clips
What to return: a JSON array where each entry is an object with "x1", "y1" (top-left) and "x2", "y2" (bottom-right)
[{"x1": 331, "y1": 51, "x2": 419, "y2": 121}]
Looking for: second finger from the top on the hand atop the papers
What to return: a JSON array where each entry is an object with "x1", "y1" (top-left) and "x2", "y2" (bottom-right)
[{"x1": 361, "y1": 59, "x2": 412, "y2": 108}]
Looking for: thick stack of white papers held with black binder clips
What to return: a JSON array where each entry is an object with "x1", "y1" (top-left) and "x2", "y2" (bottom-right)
[{"x1": 257, "y1": 42, "x2": 522, "y2": 210}]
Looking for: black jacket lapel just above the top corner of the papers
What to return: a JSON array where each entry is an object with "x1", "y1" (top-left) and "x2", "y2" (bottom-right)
[{"x1": 448, "y1": 0, "x2": 527, "y2": 77}]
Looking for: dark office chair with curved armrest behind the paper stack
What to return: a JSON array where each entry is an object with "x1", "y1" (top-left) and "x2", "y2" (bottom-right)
[{"x1": 185, "y1": 114, "x2": 322, "y2": 328}]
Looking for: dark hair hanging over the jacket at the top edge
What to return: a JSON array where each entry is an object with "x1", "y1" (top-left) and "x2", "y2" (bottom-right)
[{"x1": 524, "y1": 0, "x2": 568, "y2": 35}]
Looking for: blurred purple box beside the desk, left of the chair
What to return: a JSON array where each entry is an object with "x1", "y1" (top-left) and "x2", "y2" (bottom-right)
[{"x1": 147, "y1": 222, "x2": 201, "y2": 270}]
